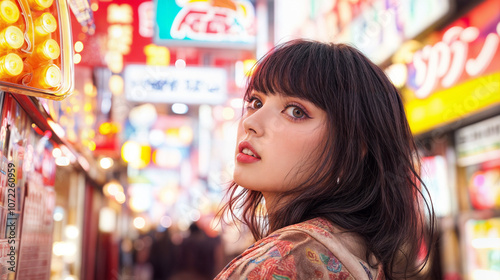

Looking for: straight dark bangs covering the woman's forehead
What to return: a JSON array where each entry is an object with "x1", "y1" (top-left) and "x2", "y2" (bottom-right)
[{"x1": 245, "y1": 41, "x2": 331, "y2": 110}]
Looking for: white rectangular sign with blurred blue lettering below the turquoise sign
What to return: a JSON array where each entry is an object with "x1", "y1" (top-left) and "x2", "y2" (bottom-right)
[{"x1": 124, "y1": 65, "x2": 227, "y2": 105}]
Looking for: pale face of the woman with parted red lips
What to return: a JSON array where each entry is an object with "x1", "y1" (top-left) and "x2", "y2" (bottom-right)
[{"x1": 234, "y1": 92, "x2": 326, "y2": 203}]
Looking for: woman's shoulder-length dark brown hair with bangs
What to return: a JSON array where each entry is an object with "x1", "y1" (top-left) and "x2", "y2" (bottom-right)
[{"x1": 223, "y1": 40, "x2": 435, "y2": 279}]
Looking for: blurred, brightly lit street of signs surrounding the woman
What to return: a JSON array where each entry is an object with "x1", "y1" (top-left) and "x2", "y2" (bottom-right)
[{"x1": 0, "y1": 0, "x2": 500, "y2": 280}]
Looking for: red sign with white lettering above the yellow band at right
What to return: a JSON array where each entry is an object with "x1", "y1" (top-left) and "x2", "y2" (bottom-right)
[{"x1": 408, "y1": 0, "x2": 500, "y2": 99}]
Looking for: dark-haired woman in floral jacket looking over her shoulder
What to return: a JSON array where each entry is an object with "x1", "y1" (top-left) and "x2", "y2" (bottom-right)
[{"x1": 216, "y1": 40, "x2": 434, "y2": 279}]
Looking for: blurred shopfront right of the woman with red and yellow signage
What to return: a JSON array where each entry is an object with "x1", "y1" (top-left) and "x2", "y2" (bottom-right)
[{"x1": 400, "y1": 1, "x2": 500, "y2": 279}]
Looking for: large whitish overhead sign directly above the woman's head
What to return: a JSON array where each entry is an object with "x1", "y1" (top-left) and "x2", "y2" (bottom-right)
[{"x1": 274, "y1": 0, "x2": 450, "y2": 64}]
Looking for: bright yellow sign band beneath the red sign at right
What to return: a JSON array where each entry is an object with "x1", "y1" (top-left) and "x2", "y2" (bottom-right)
[{"x1": 403, "y1": 73, "x2": 500, "y2": 134}]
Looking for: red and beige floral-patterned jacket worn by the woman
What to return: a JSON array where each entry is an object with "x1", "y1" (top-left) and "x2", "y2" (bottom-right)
[{"x1": 215, "y1": 218, "x2": 385, "y2": 280}]
